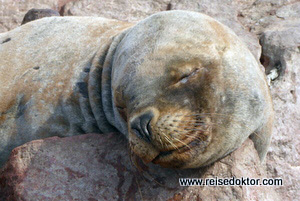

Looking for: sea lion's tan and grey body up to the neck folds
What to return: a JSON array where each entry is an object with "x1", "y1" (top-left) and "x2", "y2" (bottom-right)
[{"x1": 0, "y1": 17, "x2": 132, "y2": 165}]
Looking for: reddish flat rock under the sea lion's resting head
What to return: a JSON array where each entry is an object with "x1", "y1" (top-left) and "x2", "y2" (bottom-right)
[{"x1": 0, "y1": 133, "x2": 280, "y2": 201}]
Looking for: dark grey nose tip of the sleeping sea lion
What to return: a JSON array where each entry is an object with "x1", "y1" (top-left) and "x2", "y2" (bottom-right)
[{"x1": 130, "y1": 112, "x2": 153, "y2": 142}]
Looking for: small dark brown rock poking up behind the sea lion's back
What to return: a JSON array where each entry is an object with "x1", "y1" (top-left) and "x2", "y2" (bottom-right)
[{"x1": 22, "y1": 8, "x2": 60, "y2": 24}]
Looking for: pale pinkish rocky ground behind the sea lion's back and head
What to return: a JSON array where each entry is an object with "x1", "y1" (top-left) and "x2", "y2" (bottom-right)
[{"x1": 0, "y1": 0, "x2": 300, "y2": 200}]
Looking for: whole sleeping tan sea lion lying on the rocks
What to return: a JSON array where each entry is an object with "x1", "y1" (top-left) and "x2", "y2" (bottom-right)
[{"x1": 0, "y1": 11, "x2": 274, "y2": 168}]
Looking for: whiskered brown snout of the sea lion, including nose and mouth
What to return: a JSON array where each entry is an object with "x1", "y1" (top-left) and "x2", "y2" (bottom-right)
[{"x1": 128, "y1": 106, "x2": 212, "y2": 168}]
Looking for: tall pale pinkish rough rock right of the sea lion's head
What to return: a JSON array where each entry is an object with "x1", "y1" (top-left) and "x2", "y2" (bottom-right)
[{"x1": 260, "y1": 19, "x2": 300, "y2": 200}]
